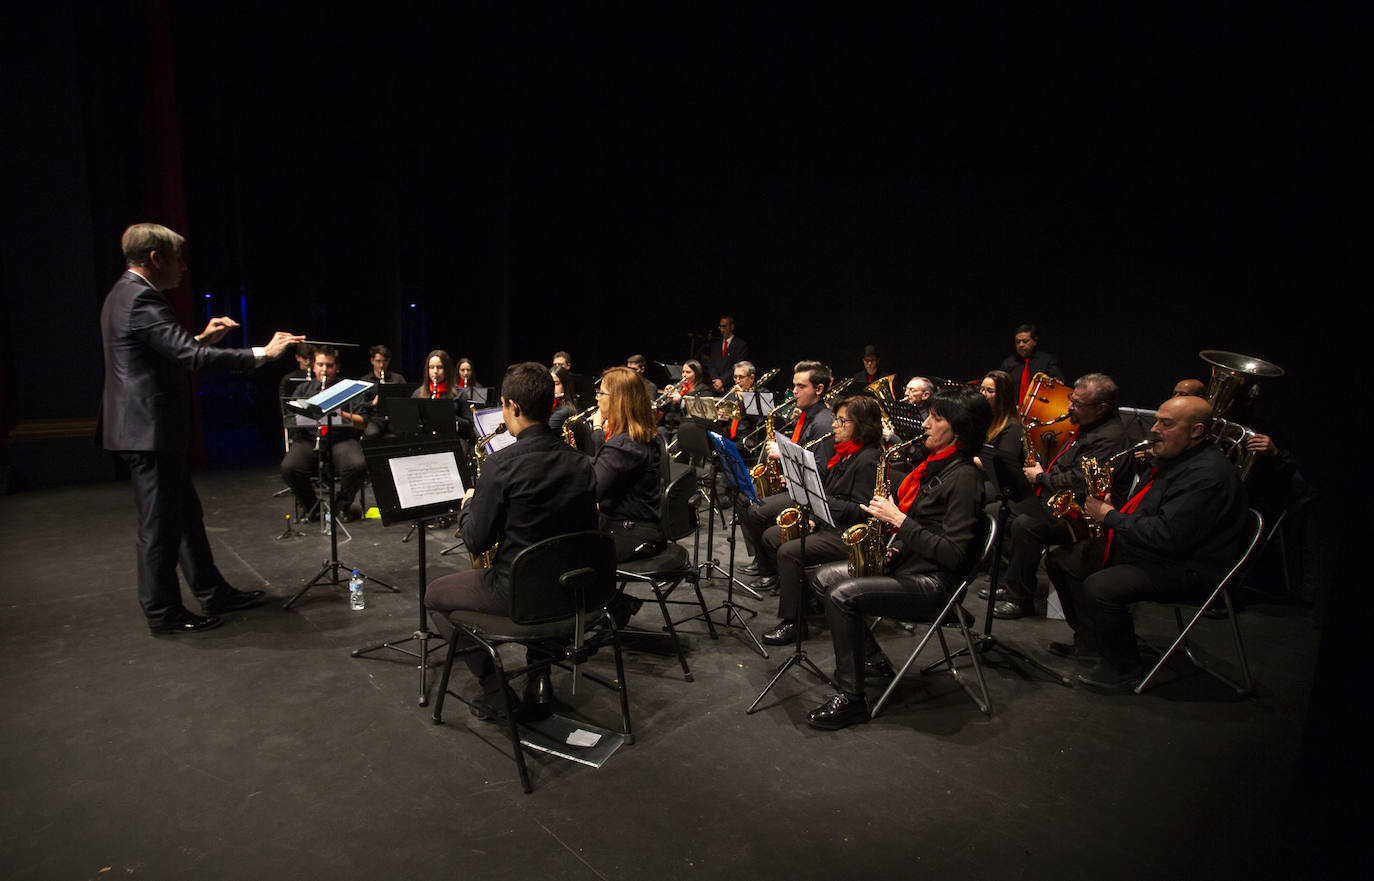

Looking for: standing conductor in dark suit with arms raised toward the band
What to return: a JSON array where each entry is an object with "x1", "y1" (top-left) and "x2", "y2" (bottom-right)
[{"x1": 98, "y1": 223, "x2": 304, "y2": 635}]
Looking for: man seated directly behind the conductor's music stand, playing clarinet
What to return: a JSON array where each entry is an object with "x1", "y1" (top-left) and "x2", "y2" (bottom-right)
[{"x1": 282, "y1": 346, "x2": 367, "y2": 522}]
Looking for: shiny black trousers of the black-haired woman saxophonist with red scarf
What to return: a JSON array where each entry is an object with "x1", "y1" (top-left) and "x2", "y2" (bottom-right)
[{"x1": 816, "y1": 564, "x2": 949, "y2": 694}]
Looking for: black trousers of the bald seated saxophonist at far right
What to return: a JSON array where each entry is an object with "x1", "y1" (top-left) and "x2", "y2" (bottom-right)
[{"x1": 1046, "y1": 542, "x2": 1208, "y2": 672}]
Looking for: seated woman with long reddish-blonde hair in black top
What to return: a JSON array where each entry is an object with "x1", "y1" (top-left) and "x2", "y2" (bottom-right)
[{"x1": 592, "y1": 367, "x2": 665, "y2": 562}]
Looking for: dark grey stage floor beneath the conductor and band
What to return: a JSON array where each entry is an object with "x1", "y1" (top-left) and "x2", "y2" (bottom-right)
[{"x1": 0, "y1": 469, "x2": 1320, "y2": 881}]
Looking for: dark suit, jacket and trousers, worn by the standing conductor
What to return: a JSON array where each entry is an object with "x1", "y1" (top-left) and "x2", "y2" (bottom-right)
[{"x1": 99, "y1": 272, "x2": 256, "y2": 627}]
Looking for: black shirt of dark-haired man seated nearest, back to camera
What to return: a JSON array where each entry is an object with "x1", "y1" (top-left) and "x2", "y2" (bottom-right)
[{"x1": 458, "y1": 423, "x2": 596, "y2": 601}]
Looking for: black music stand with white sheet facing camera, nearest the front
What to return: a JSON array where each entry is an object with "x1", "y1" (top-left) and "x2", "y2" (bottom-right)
[{"x1": 353, "y1": 428, "x2": 464, "y2": 706}]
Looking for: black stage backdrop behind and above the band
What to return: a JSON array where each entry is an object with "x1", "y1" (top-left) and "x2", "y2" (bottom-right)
[{"x1": 0, "y1": 1, "x2": 1352, "y2": 481}]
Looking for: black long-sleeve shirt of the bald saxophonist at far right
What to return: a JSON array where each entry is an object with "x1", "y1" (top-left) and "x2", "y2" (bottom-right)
[{"x1": 1103, "y1": 441, "x2": 1246, "y2": 580}]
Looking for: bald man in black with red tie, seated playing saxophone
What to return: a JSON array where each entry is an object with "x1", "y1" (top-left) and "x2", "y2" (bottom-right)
[{"x1": 1046, "y1": 396, "x2": 1246, "y2": 690}]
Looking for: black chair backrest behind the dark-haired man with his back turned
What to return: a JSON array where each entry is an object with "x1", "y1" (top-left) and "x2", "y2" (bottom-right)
[{"x1": 511, "y1": 531, "x2": 616, "y2": 624}]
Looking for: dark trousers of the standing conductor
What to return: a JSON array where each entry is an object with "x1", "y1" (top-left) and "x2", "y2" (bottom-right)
[{"x1": 118, "y1": 451, "x2": 224, "y2": 625}]
